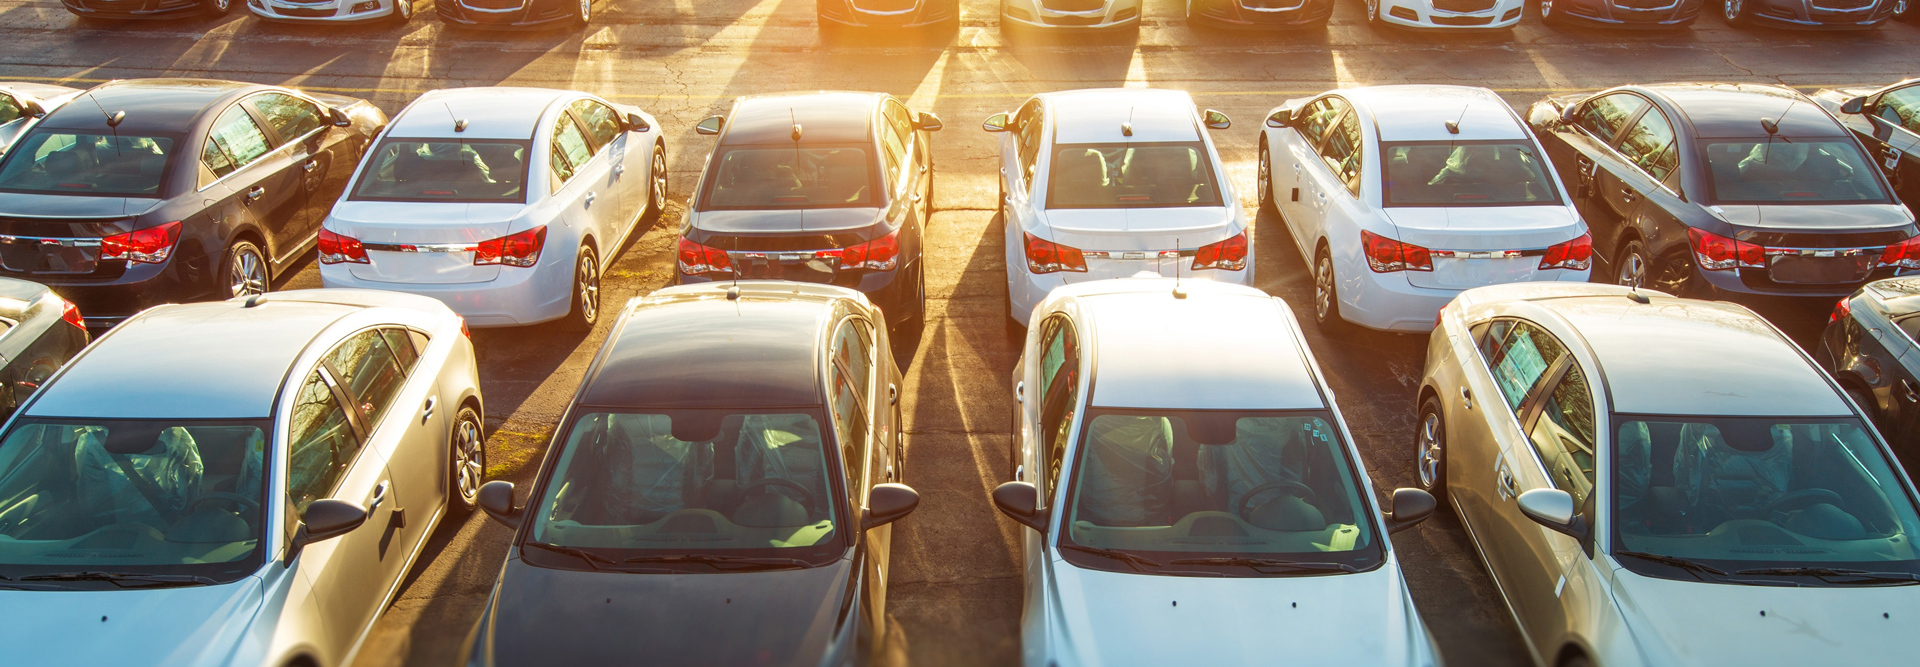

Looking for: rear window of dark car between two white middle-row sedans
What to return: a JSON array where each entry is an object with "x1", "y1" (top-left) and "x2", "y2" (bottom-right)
[{"x1": 701, "y1": 144, "x2": 879, "y2": 211}]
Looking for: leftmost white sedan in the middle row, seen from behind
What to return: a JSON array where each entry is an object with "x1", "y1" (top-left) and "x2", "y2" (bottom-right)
[{"x1": 319, "y1": 88, "x2": 666, "y2": 329}]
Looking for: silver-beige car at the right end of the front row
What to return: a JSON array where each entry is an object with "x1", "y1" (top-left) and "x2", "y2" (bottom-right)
[{"x1": 1417, "y1": 283, "x2": 1920, "y2": 667}]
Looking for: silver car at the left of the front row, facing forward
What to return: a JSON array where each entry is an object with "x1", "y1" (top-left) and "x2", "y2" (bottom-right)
[{"x1": 0, "y1": 290, "x2": 484, "y2": 667}]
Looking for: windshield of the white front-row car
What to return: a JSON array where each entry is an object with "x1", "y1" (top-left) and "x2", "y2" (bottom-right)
[{"x1": 1060, "y1": 409, "x2": 1382, "y2": 575}]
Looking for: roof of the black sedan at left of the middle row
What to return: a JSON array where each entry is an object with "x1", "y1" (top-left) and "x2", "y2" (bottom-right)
[{"x1": 40, "y1": 79, "x2": 257, "y2": 135}]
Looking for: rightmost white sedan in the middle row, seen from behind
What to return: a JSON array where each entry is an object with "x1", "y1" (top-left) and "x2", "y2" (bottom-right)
[{"x1": 1258, "y1": 86, "x2": 1594, "y2": 331}]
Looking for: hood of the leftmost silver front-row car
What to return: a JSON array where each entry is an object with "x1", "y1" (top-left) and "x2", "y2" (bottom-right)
[{"x1": 0, "y1": 577, "x2": 263, "y2": 665}]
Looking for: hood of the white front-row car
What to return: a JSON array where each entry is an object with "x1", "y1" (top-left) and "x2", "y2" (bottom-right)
[{"x1": 1052, "y1": 561, "x2": 1430, "y2": 665}]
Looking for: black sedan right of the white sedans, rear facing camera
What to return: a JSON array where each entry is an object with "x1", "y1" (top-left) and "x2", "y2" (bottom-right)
[{"x1": 1528, "y1": 85, "x2": 1920, "y2": 300}]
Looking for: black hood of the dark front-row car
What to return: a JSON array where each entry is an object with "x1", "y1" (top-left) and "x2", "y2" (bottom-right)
[{"x1": 480, "y1": 559, "x2": 852, "y2": 667}]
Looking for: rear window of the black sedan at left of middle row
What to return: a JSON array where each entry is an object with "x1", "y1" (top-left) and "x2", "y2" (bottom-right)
[{"x1": 0, "y1": 129, "x2": 173, "y2": 196}]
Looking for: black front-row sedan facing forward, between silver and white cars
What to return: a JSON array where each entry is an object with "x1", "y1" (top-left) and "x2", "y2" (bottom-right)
[{"x1": 467, "y1": 281, "x2": 920, "y2": 667}]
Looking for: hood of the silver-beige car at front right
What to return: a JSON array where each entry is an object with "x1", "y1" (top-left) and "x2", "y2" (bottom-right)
[{"x1": 1613, "y1": 569, "x2": 1920, "y2": 667}]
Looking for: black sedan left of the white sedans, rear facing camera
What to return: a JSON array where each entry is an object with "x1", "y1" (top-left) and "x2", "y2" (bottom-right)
[{"x1": 0, "y1": 79, "x2": 386, "y2": 327}]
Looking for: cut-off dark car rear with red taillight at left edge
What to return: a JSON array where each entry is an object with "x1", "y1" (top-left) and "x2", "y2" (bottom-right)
[{"x1": 0, "y1": 279, "x2": 86, "y2": 421}]
